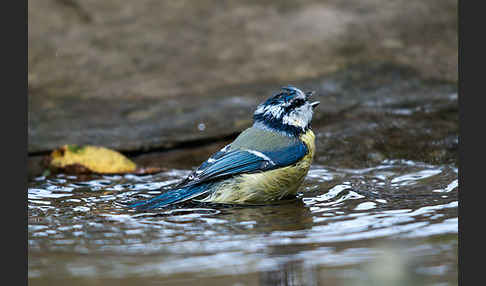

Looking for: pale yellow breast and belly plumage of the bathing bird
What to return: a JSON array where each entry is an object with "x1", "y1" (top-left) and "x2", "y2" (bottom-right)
[{"x1": 203, "y1": 129, "x2": 315, "y2": 204}]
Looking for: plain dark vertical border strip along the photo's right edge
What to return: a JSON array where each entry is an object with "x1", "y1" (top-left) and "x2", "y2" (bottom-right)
[{"x1": 457, "y1": 0, "x2": 470, "y2": 285}]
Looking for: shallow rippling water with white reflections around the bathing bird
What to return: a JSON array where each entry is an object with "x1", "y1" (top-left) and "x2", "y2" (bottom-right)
[{"x1": 28, "y1": 160, "x2": 458, "y2": 285}]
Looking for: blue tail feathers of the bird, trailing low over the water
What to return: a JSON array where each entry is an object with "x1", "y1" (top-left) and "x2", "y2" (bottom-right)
[{"x1": 129, "y1": 184, "x2": 209, "y2": 210}]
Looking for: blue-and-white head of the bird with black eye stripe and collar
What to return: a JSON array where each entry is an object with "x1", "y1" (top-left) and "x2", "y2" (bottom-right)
[{"x1": 253, "y1": 85, "x2": 319, "y2": 135}]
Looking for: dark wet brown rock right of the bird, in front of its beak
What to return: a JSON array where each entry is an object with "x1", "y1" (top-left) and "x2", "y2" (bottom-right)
[{"x1": 309, "y1": 64, "x2": 459, "y2": 168}]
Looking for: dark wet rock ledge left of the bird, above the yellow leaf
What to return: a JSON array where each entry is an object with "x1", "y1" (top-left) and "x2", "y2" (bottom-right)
[{"x1": 29, "y1": 88, "x2": 256, "y2": 153}]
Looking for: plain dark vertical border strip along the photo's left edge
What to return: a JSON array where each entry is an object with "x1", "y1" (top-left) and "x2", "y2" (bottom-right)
[{"x1": 19, "y1": 0, "x2": 28, "y2": 285}]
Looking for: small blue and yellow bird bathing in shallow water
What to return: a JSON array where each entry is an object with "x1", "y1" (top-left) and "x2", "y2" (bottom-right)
[{"x1": 129, "y1": 85, "x2": 319, "y2": 210}]
